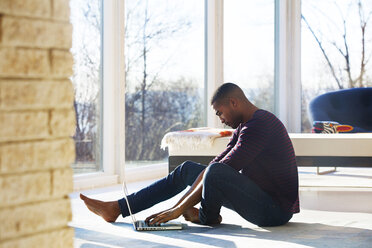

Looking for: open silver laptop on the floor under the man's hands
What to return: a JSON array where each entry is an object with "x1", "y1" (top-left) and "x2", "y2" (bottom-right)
[{"x1": 123, "y1": 180, "x2": 182, "y2": 231}]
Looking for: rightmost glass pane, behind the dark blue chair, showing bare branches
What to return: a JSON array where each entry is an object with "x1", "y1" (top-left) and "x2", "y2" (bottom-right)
[{"x1": 301, "y1": 0, "x2": 372, "y2": 132}]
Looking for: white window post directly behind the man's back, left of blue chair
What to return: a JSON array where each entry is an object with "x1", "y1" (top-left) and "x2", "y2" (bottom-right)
[{"x1": 275, "y1": 0, "x2": 301, "y2": 132}]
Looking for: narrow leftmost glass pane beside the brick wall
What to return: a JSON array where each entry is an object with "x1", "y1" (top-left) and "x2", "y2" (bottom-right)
[{"x1": 70, "y1": 0, "x2": 102, "y2": 173}]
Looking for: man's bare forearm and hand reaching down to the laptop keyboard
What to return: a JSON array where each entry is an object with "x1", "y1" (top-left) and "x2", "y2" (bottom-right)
[{"x1": 146, "y1": 169, "x2": 205, "y2": 224}]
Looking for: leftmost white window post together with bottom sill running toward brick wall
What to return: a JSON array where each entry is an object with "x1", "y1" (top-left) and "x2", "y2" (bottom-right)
[{"x1": 74, "y1": 0, "x2": 125, "y2": 190}]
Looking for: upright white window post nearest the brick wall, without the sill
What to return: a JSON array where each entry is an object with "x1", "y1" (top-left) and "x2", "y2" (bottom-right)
[{"x1": 102, "y1": 0, "x2": 125, "y2": 178}]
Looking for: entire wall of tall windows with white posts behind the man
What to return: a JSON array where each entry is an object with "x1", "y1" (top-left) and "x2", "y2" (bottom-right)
[{"x1": 71, "y1": 0, "x2": 372, "y2": 187}]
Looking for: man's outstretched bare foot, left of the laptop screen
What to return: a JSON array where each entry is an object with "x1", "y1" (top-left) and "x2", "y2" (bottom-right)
[{"x1": 80, "y1": 194, "x2": 120, "y2": 222}]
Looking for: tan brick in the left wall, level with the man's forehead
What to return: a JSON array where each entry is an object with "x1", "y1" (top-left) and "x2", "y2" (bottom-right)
[{"x1": 0, "y1": 80, "x2": 74, "y2": 110}]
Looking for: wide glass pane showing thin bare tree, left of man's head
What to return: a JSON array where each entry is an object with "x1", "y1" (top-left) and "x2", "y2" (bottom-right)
[{"x1": 125, "y1": 0, "x2": 204, "y2": 168}]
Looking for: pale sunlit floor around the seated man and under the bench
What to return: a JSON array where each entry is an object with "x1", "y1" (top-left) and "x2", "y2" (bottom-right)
[{"x1": 70, "y1": 168, "x2": 372, "y2": 248}]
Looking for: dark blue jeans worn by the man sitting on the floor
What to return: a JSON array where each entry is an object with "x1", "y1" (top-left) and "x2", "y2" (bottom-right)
[{"x1": 119, "y1": 161, "x2": 292, "y2": 226}]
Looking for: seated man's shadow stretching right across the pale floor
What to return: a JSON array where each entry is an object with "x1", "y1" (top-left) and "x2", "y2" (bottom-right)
[{"x1": 107, "y1": 222, "x2": 372, "y2": 247}]
